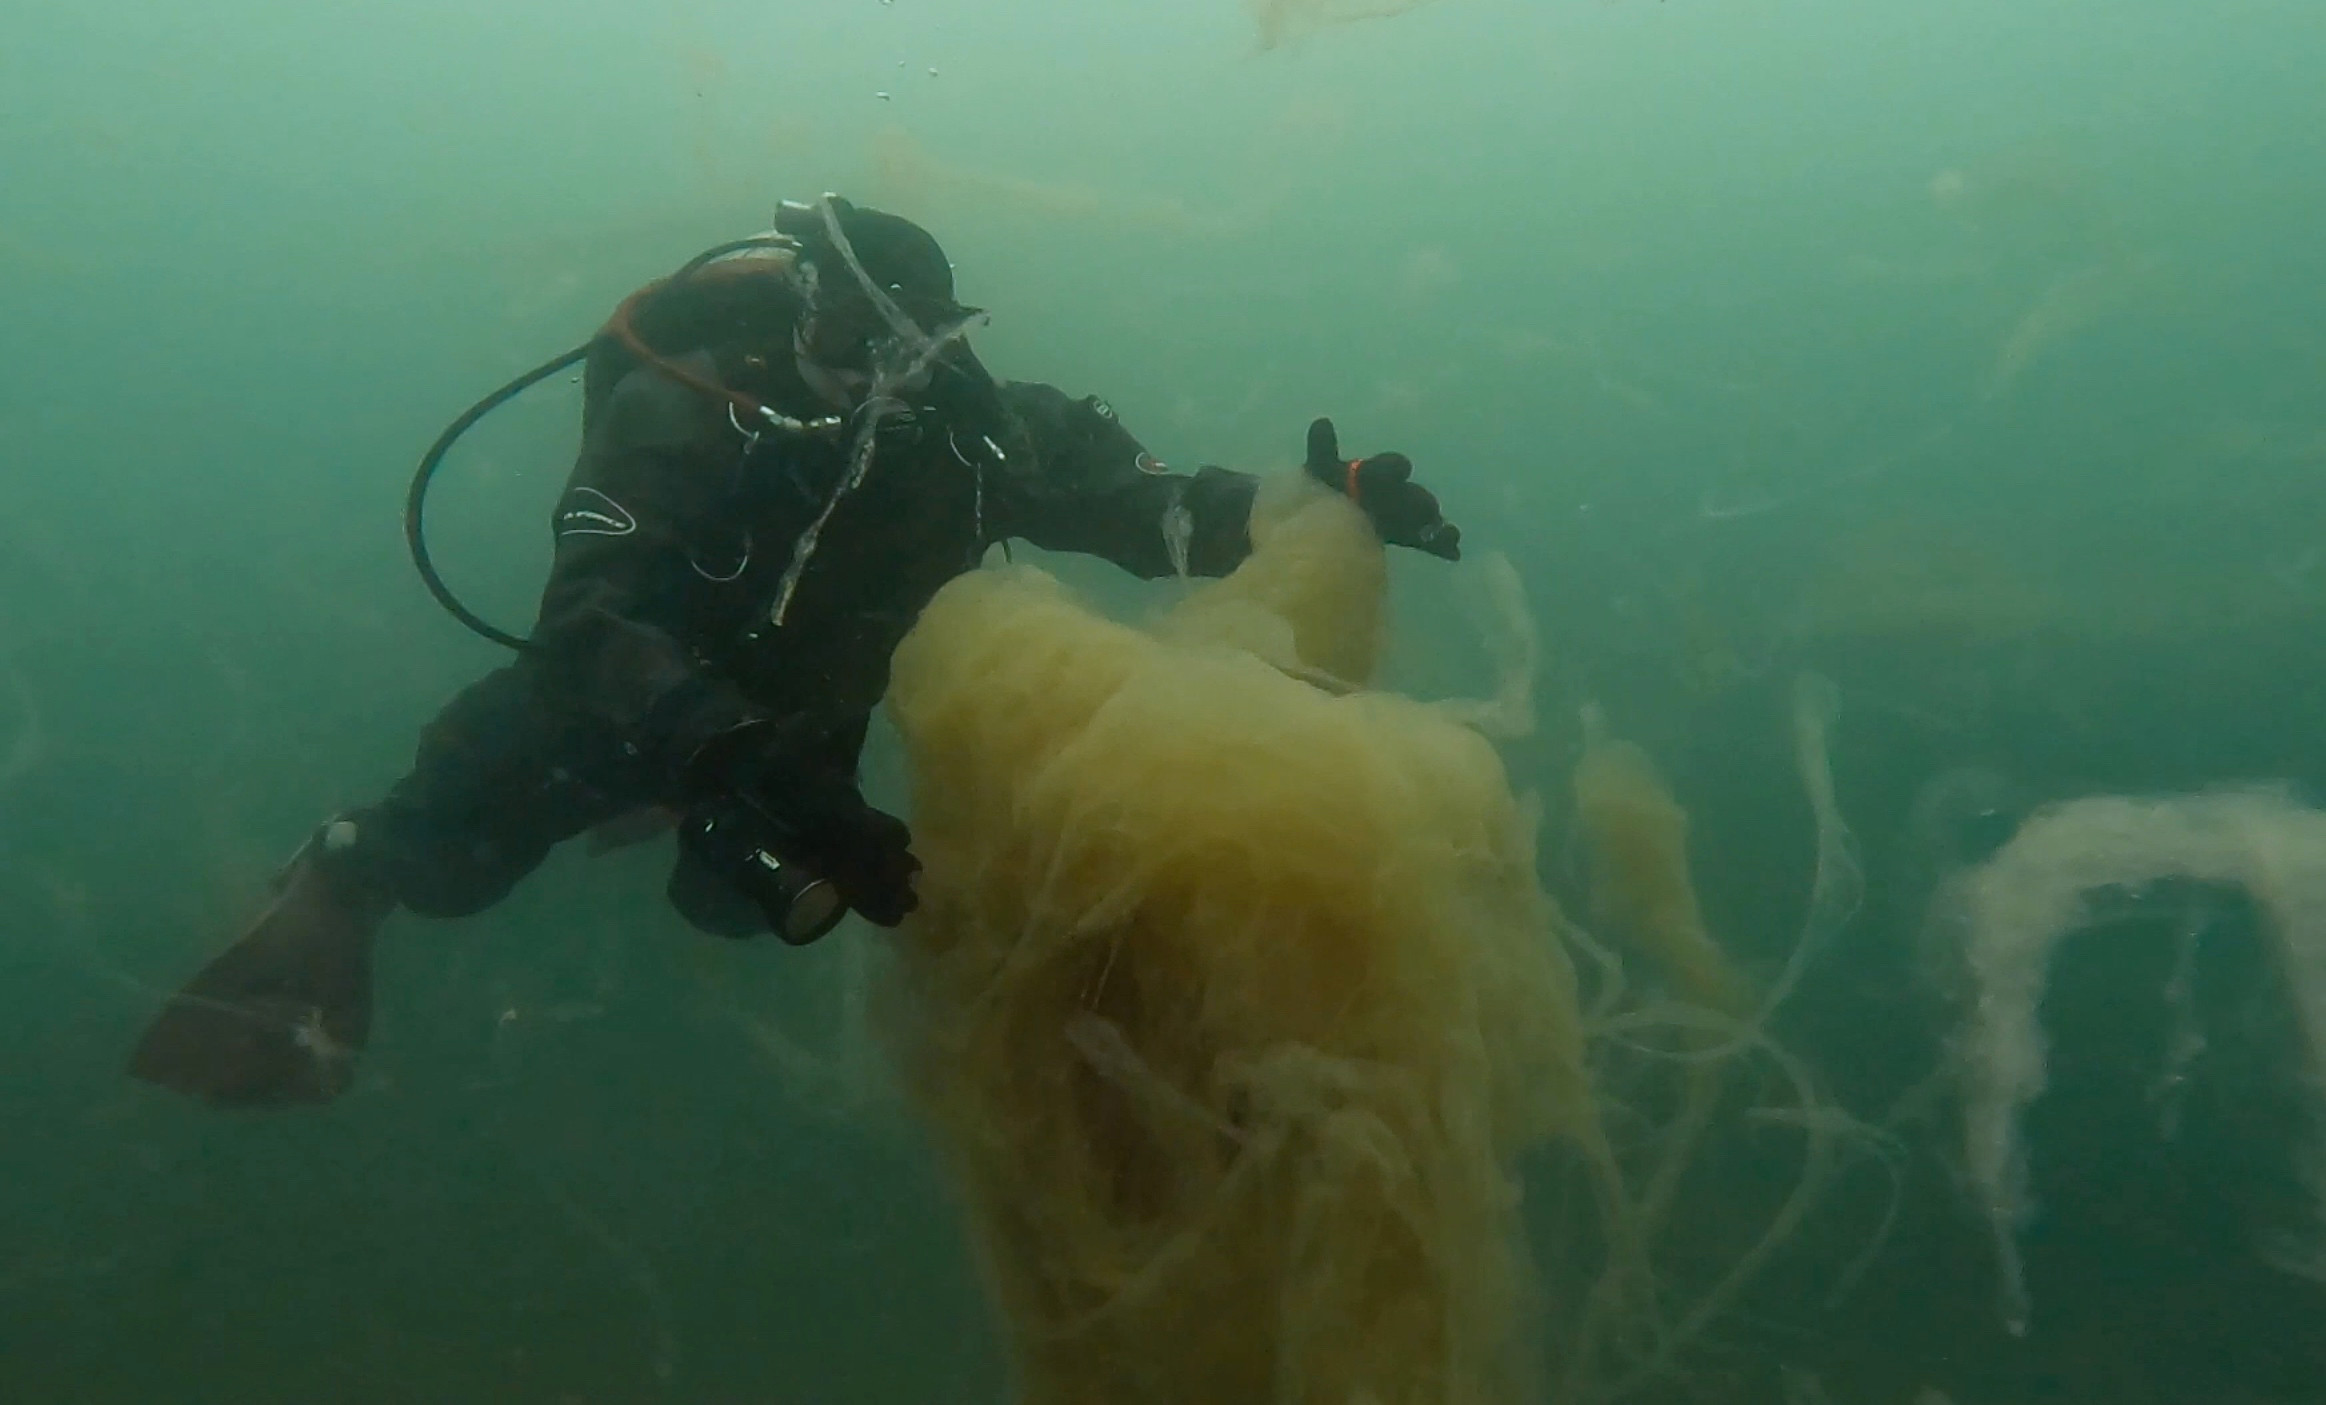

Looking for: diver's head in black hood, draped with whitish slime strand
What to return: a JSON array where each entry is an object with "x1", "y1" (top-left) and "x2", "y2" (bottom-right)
[{"x1": 775, "y1": 195, "x2": 977, "y2": 400}]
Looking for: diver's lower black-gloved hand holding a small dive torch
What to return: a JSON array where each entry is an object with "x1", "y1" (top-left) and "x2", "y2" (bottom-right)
[{"x1": 672, "y1": 723, "x2": 921, "y2": 942}]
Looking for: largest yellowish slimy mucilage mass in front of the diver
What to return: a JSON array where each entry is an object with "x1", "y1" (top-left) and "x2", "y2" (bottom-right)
[{"x1": 891, "y1": 479, "x2": 1607, "y2": 1405}]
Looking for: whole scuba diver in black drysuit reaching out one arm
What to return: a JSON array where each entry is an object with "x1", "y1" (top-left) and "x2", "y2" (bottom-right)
[{"x1": 130, "y1": 195, "x2": 1461, "y2": 1107}]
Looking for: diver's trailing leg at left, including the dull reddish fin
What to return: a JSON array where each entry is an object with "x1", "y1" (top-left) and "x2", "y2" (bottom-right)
[{"x1": 130, "y1": 663, "x2": 642, "y2": 1107}]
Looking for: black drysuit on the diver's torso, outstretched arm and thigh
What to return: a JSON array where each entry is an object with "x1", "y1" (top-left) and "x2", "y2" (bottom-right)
[{"x1": 333, "y1": 279, "x2": 1254, "y2": 917}]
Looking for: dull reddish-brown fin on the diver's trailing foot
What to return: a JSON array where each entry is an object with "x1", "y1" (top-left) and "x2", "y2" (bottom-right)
[{"x1": 130, "y1": 821, "x2": 395, "y2": 1107}]
